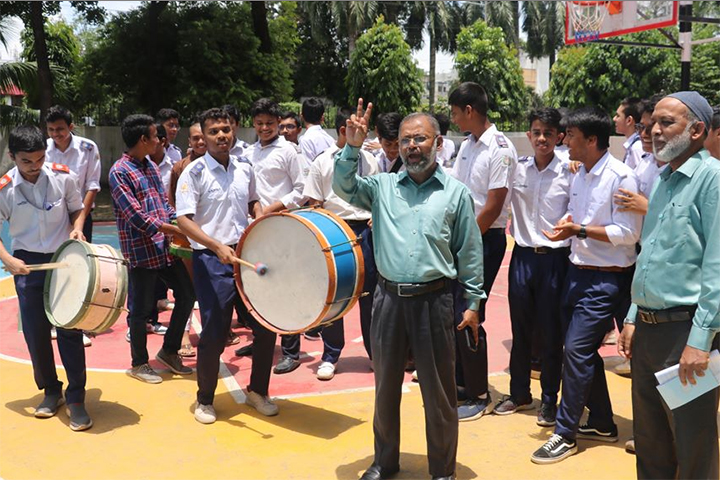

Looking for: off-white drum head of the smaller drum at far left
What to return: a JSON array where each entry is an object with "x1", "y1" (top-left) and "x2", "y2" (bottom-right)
[{"x1": 45, "y1": 241, "x2": 95, "y2": 328}]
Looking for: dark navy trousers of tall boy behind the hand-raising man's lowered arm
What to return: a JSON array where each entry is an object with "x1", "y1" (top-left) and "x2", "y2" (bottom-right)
[{"x1": 453, "y1": 228, "x2": 500, "y2": 398}]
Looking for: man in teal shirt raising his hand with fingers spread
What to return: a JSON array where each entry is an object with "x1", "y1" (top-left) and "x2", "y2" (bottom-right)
[{"x1": 333, "y1": 99, "x2": 485, "y2": 480}]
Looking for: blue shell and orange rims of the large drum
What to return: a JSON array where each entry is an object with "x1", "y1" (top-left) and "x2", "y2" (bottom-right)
[{"x1": 235, "y1": 208, "x2": 364, "y2": 334}]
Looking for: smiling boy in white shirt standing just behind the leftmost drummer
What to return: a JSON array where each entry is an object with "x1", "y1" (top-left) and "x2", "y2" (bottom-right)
[{"x1": 45, "y1": 105, "x2": 102, "y2": 242}]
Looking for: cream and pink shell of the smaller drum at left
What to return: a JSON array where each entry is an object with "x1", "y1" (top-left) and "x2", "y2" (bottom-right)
[{"x1": 43, "y1": 240, "x2": 128, "y2": 333}]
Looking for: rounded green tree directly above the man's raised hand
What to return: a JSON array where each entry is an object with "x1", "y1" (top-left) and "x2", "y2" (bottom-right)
[{"x1": 346, "y1": 16, "x2": 423, "y2": 123}]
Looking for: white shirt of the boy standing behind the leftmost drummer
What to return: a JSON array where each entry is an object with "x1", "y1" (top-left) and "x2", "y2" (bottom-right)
[{"x1": 45, "y1": 134, "x2": 102, "y2": 202}]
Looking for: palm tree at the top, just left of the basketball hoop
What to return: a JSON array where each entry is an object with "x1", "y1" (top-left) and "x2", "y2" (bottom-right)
[{"x1": 522, "y1": 2, "x2": 565, "y2": 69}]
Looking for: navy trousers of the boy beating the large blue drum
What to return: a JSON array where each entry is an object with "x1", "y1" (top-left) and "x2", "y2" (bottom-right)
[{"x1": 192, "y1": 250, "x2": 276, "y2": 405}]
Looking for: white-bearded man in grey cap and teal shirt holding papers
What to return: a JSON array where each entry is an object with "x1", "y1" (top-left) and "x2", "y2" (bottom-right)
[{"x1": 618, "y1": 92, "x2": 720, "y2": 478}]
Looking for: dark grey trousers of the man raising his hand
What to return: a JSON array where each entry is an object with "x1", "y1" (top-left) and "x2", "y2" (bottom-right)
[{"x1": 370, "y1": 285, "x2": 458, "y2": 477}]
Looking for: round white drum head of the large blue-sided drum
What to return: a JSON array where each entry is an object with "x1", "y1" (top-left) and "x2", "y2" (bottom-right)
[{"x1": 240, "y1": 215, "x2": 335, "y2": 332}]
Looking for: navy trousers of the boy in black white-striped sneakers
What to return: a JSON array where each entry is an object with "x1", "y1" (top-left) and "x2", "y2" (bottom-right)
[{"x1": 555, "y1": 264, "x2": 632, "y2": 439}]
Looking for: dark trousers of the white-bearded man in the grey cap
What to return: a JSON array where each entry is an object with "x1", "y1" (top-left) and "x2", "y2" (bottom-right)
[{"x1": 631, "y1": 321, "x2": 720, "y2": 479}]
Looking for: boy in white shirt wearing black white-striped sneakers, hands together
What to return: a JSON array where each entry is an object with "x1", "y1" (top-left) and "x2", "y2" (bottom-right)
[{"x1": 531, "y1": 107, "x2": 642, "y2": 464}]
